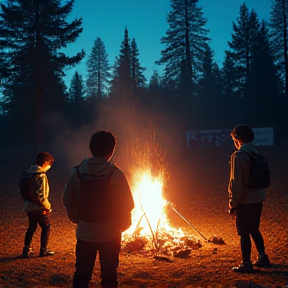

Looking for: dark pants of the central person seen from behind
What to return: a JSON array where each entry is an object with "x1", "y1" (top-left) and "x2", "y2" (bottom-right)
[{"x1": 73, "y1": 239, "x2": 121, "y2": 288}]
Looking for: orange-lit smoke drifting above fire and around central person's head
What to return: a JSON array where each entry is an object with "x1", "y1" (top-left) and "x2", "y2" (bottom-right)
[{"x1": 45, "y1": 101, "x2": 181, "y2": 173}]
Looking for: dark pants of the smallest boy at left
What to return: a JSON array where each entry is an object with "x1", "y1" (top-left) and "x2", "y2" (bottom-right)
[{"x1": 24, "y1": 211, "x2": 51, "y2": 248}]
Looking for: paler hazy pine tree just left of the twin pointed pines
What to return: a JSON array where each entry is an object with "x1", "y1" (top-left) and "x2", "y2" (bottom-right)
[{"x1": 86, "y1": 37, "x2": 111, "y2": 99}]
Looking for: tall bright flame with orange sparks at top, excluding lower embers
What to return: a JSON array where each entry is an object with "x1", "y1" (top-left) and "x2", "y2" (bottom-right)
[{"x1": 122, "y1": 127, "x2": 187, "y2": 251}]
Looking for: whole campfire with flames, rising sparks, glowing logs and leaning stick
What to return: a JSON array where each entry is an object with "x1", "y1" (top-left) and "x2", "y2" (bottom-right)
[{"x1": 122, "y1": 127, "x2": 209, "y2": 261}]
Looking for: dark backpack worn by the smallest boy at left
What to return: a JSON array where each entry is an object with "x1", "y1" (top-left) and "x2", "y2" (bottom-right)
[{"x1": 18, "y1": 171, "x2": 44, "y2": 202}]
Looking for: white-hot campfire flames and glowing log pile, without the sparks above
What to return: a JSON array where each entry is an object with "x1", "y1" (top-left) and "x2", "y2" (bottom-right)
[{"x1": 123, "y1": 166, "x2": 202, "y2": 260}]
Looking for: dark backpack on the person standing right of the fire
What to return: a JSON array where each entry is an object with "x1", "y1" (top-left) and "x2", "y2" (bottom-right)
[{"x1": 243, "y1": 151, "x2": 270, "y2": 188}]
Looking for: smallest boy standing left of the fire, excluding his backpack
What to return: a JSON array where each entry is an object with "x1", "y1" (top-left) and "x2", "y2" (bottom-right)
[{"x1": 22, "y1": 152, "x2": 54, "y2": 258}]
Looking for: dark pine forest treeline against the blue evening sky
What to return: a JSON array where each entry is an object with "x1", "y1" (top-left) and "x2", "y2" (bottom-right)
[{"x1": 0, "y1": 0, "x2": 288, "y2": 145}]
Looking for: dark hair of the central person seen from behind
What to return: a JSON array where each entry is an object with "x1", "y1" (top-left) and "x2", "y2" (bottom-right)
[{"x1": 89, "y1": 130, "x2": 116, "y2": 158}]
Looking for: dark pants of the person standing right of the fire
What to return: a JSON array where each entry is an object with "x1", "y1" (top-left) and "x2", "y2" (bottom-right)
[{"x1": 236, "y1": 203, "x2": 265, "y2": 262}]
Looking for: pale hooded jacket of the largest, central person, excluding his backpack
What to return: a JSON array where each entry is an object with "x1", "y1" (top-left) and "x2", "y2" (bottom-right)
[{"x1": 62, "y1": 157, "x2": 134, "y2": 242}]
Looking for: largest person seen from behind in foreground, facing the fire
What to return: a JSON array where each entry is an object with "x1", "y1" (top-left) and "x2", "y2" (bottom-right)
[{"x1": 63, "y1": 130, "x2": 134, "y2": 288}]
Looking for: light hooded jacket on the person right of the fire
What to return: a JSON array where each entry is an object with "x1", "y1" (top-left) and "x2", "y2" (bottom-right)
[{"x1": 228, "y1": 143, "x2": 266, "y2": 209}]
